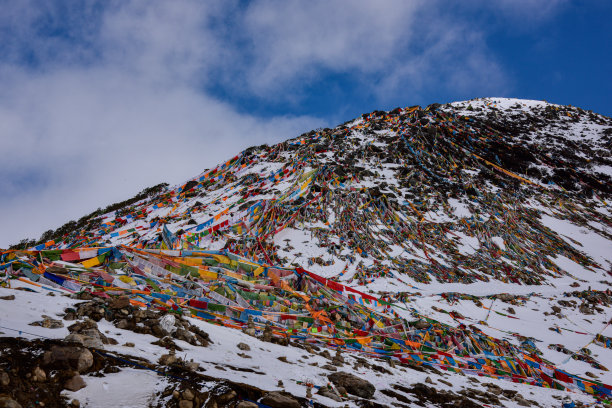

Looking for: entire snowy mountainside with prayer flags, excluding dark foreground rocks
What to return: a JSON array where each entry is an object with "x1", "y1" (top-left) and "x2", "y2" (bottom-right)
[{"x1": 0, "y1": 98, "x2": 612, "y2": 406}]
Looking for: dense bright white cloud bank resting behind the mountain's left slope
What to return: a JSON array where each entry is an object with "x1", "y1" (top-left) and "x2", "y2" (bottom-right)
[{"x1": 0, "y1": 69, "x2": 324, "y2": 246}]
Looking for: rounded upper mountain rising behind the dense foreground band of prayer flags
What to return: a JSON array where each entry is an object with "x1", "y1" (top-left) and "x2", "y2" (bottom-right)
[{"x1": 10, "y1": 98, "x2": 612, "y2": 290}]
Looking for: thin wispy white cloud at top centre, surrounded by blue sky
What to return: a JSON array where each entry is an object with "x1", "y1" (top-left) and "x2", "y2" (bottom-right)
[{"x1": 235, "y1": 0, "x2": 424, "y2": 95}]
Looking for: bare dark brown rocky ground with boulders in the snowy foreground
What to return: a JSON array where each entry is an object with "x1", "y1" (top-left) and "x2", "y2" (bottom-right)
[{"x1": 0, "y1": 296, "x2": 580, "y2": 408}]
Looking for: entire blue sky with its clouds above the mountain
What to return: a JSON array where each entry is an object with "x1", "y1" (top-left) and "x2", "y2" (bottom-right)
[{"x1": 0, "y1": 0, "x2": 612, "y2": 247}]
